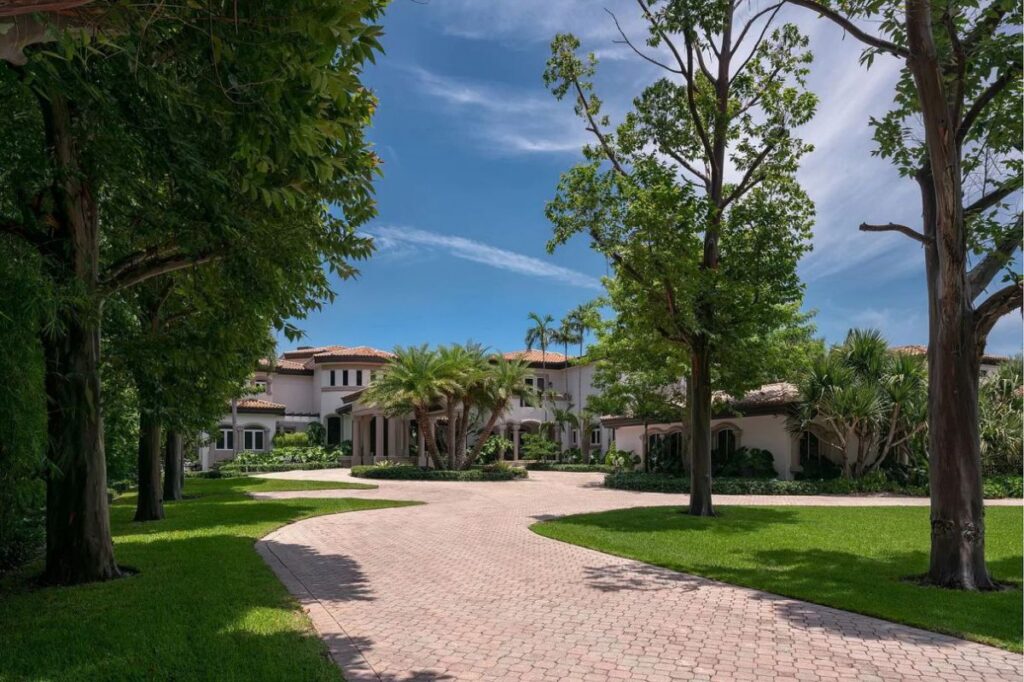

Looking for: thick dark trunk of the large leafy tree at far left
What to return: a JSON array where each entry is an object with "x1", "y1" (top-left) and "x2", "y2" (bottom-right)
[{"x1": 39, "y1": 87, "x2": 120, "y2": 585}]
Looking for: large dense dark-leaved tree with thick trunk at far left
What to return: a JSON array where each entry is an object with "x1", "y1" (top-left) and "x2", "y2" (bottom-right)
[{"x1": 0, "y1": 0, "x2": 381, "y2": 583}]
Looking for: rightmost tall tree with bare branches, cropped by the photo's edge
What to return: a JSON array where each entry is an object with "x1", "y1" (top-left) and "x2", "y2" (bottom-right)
[{"x1": 787, "y1": 0, "x2": 1024, "y2": 590}]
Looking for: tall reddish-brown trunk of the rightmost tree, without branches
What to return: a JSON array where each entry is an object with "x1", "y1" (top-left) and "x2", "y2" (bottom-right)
[{"x1": 906, "y1": 0, "x2": 994, "y2": 590}]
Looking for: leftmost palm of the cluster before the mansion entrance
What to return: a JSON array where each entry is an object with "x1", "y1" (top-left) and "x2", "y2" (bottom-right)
[{"x1": 362, "y1": 344, "x2": 452, "y2": 469}]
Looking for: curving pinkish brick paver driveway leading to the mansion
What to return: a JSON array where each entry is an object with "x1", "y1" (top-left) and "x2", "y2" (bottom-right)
[{"x1": 257, "y1": 470, "x2": 1022, "y2": 682}]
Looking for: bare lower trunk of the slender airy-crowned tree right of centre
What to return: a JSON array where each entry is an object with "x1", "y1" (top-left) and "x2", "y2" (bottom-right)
[{"x1": 689, "y1": 338, "x2": 715, "y2": 516}]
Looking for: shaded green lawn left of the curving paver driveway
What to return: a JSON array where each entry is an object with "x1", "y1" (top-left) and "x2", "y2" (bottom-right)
[{"x1": 0, "y1": 478, "x2": 409, "y2": 681}]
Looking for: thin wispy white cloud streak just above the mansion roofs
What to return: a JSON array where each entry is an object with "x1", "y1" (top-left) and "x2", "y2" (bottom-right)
[{"x1": 368, "y1": 225, "x2": 602, "y2": 290}]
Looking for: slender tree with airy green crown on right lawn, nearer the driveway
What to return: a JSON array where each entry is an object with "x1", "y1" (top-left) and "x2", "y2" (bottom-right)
[{"x1": 545, "y1": 0, "x2": 816, "y2": 515}]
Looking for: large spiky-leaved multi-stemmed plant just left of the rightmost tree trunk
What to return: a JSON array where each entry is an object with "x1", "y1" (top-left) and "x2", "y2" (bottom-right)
[{"x1": 794, "y1": 330, "x2": 928, "y2": 478}]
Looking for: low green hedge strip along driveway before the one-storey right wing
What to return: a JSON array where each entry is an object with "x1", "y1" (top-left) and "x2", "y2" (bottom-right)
[{"x1": 604, "y1": 472, "x2": 1024, "y2": 498}]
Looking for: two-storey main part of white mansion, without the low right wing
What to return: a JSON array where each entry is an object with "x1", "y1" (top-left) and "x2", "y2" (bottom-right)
[{"x1": 199, "y1": 346, "x2": 611, "y2": 469}]
